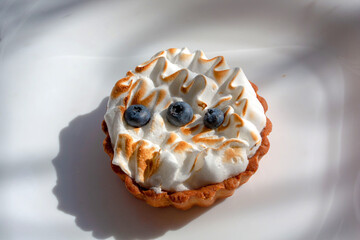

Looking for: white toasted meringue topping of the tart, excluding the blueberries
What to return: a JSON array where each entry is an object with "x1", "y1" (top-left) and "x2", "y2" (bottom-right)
[{"x1": 105, "y1": 48, "x2": 266, "y2": 191}]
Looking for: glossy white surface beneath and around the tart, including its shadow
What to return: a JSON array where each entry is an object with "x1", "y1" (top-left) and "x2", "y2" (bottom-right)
[{"x1": 0, "y1": 0, "x2": 360, "y2": 239}]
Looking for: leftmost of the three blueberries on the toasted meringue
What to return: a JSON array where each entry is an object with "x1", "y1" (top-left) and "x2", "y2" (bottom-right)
[{"x1": 124, "y1": 104, "x2": 151, "y2": 127}]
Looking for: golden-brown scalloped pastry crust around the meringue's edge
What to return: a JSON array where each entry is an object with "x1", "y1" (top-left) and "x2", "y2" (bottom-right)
[{"x1": 102, "y1": 82, "x2": 272, "y2": 210}]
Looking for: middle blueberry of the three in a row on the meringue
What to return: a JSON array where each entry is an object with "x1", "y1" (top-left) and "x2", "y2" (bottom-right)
[{"x1": 166, "y1": 102, "x2": 193, "y2": 127}]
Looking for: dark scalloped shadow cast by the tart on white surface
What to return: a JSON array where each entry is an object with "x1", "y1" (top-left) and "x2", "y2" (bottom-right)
[{"x1": 53, "y1": 98, "x2": 209, "y2": 239}]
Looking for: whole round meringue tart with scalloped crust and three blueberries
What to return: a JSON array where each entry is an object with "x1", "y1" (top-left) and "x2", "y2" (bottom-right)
[{"x1": 102, "y1": 48, "x2": 272, "y2": 209}]
